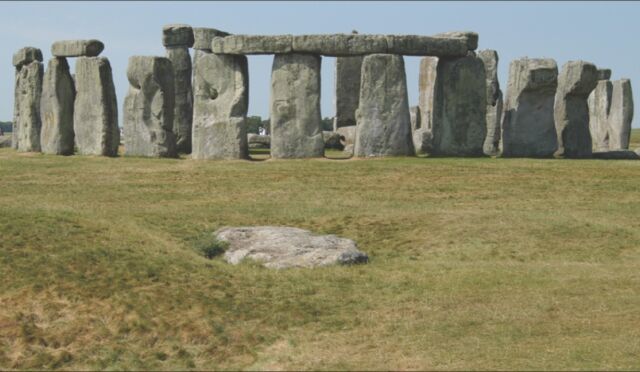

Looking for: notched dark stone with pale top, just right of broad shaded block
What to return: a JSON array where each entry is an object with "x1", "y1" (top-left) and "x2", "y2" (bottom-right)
[{"x1": 554, "y1": 61, "x2": 598, "y2": 158}]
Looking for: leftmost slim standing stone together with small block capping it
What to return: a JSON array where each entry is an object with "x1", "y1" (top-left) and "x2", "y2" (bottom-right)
[{"x1": 12, "y1": 47, "x2": 44, "y2": 152}]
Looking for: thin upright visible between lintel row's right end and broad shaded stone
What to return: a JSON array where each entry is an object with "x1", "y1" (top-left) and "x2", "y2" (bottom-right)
[{"x1": 478, "y1": 50, "x2": 502, "y2": 156}]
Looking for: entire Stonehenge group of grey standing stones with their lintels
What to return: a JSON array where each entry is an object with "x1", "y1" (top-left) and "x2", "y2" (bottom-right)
[{"x1": 12, "y1": 28, "x2": 636, "y2": 163}]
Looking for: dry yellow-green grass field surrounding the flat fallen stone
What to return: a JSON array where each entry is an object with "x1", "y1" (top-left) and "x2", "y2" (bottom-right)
[{"x1": 0, "y1": 131, "x2": 640, "y2": 370}]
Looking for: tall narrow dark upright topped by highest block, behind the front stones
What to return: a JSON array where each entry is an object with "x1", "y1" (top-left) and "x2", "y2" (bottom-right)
[{"x1": 162, "y1": 25, "x2": 194, "y2": 154}]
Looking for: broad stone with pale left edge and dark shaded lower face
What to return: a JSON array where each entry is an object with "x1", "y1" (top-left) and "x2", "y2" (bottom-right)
[{"x1": 502, "y1": 58, "x2": 558, "y2": 157}]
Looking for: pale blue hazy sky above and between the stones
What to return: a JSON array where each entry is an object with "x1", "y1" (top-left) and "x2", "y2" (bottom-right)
[{"x1": 0, "y1": 1, "x2": 640, "y2": 127}]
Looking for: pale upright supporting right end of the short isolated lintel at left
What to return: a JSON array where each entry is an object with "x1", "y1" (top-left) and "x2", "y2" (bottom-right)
[{"x1": 73, "y1": 57, "x2": 120, "y2": 156}]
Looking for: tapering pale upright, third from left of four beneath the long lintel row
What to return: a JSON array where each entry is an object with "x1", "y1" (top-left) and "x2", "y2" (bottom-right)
[{"x1": 354, "y1": 54, "x2": 415, "y2": 157}]
